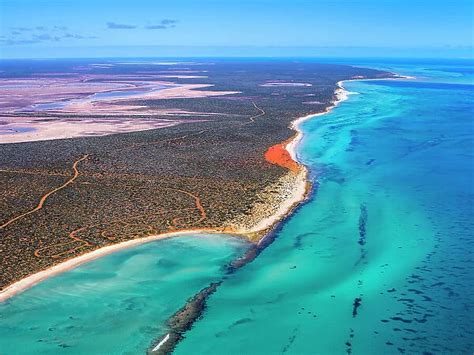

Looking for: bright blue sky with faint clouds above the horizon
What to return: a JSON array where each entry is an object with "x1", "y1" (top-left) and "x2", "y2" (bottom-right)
[{"x1": 0, "y1": 0, "x2": 474, "y2": 58}]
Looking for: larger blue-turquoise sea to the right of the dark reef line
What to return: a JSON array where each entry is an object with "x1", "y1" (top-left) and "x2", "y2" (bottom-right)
[{"x1": 176, "y1": 59, "x2": 474, "y2": 354}]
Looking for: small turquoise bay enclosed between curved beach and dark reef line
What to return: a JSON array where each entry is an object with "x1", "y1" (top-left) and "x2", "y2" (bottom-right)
[{"x1": 0, "y1": 235, "x2": 247, "y2": 354}]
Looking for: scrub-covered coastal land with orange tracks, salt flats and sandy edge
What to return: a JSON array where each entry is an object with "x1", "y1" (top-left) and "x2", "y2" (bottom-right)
[{"x1": 0, "y1": 61, "x2": 393, "y2": 301}]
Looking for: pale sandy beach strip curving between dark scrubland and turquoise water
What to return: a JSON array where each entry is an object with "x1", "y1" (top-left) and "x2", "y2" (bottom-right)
[{"x1": 0, "y1": 79, "x2": 352, "y2": 302}]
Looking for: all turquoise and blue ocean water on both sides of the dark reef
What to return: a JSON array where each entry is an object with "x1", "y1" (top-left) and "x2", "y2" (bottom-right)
[{"x1": 0, "y1": 61, "x2": 474, "y2": 354}]
